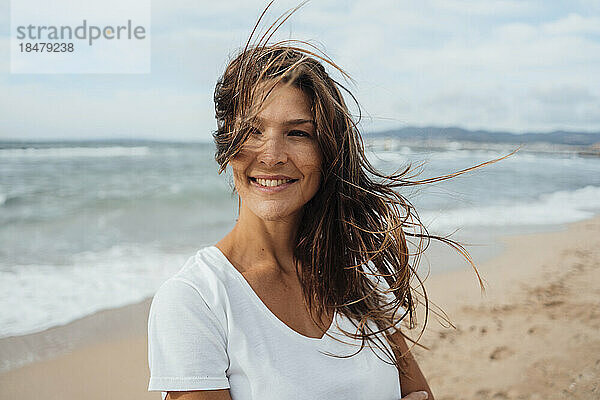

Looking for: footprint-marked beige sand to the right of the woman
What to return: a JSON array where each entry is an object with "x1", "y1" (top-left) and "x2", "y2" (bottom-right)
[{"x1": 413, "y1": 217, "x2": 600, "y2": 400}]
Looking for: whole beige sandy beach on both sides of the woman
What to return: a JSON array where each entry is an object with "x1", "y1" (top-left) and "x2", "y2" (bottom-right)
[{"x1": 0, "y1": 216, "x2": 600, "y2": 400}]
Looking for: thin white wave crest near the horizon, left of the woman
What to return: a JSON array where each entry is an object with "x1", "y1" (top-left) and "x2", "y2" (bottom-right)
[{"x1": 0, "y1": 146, "x2": 150, "y2": 158}]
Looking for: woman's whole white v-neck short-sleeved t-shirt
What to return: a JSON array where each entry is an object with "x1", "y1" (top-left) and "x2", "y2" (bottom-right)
[{"x1": 148, "y1": 246, "x2": 401, "y2": 400}]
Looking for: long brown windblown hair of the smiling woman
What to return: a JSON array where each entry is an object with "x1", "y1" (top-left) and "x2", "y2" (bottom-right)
[{"x1": 213, "y1": 1, "x2": 518, "y2": 378}]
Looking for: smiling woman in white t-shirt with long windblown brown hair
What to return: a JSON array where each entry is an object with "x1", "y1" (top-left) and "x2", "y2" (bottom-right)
[{"x1": 149, "y1": 1, "x2": 516, "y2": 400}]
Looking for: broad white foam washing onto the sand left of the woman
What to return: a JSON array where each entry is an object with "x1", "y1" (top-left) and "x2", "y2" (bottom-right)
[{"x1": 0, "y1": 242, "x2": 185, "y2": 338}]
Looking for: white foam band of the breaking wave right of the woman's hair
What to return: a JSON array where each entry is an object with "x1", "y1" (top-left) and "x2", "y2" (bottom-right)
[{"x1": 419, "y1": 185, "x2": 600, "y2": 231}]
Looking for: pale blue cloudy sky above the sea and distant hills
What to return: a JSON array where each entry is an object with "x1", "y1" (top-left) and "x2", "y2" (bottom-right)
[{"x1": 0, "y1": 0, "x2": 600, "y2": 141}]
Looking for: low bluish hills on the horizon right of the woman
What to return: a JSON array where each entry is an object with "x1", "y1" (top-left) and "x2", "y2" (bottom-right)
[{"x1": 365, "y1": 127, "x2": 600, "y2": 146}]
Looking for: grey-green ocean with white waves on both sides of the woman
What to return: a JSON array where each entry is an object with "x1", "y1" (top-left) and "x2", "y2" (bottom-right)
[{"x1": 0, "y1": 141, "x2": 600, "y2": 338}]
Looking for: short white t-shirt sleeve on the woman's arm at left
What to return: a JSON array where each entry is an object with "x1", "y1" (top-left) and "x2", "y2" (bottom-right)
[{"x1": 148, "y1": 278, "x2": 229, "y2": 399}]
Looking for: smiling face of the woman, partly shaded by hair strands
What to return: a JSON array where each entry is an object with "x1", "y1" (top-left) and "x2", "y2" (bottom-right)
[{"x1": 231, "y1": 83, "x2": 321, "y2": 221}]
